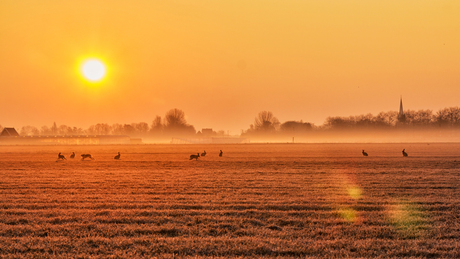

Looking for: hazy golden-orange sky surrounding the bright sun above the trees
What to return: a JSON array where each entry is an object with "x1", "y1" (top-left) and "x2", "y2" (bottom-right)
[{"x1": 0, "y1": 0, "x2": 460, "y2": 134}]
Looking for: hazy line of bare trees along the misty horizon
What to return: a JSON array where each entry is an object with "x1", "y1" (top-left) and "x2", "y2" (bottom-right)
[{"x1": 5, "y1": 107, "x2": 460, "y2": 137}]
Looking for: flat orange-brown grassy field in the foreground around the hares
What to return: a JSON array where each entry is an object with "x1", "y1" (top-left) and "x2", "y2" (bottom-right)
[{"x1": 0, "y1": 144, "x2": 460, "y2": 258}]
